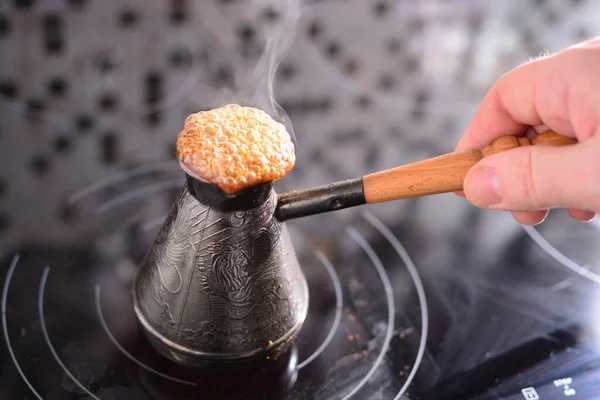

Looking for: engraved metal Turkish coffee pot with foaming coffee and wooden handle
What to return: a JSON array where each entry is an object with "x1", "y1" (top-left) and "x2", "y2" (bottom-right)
[{"x1": 134, "y1": 105, "x2": 576, "y2": 367}]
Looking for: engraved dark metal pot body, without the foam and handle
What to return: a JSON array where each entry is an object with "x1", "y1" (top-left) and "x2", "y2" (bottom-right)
[{"x1": 134, "y1": 176, "x2": 308, "y2": 367}]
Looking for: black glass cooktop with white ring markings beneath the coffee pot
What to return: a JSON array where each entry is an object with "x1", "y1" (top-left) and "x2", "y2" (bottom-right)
[{"x1": 0, "y1": 188, "x2": 600, "y2": 400}]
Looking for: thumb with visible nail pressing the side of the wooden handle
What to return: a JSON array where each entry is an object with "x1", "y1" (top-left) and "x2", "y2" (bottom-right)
[{"x1": 464, "y1": 137, "x2": 600, "y2": 212}]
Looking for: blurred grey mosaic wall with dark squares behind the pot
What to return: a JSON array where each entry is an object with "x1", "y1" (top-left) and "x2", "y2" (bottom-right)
[{"x1": 0, "y1": 0, "x2": 600, "y2": 254}]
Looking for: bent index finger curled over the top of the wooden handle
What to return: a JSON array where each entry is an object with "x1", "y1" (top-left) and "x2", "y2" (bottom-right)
[{"x1": 456, "y1": 41, "x2": 600, "y2": 151}]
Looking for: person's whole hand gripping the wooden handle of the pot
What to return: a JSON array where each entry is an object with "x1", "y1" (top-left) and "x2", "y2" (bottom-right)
[{"x1": 456, "y1": 39, "x2": 600, "y2": 225}]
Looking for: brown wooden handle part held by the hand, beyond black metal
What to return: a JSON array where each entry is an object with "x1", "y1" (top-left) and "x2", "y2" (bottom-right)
[{"x1": 363, "y1": 131, "x2": 577, "y2": 203}]
